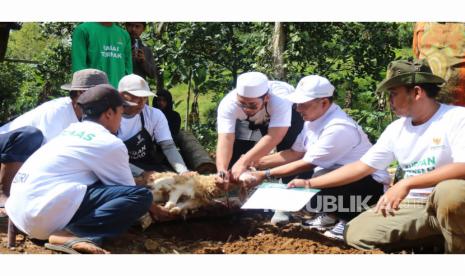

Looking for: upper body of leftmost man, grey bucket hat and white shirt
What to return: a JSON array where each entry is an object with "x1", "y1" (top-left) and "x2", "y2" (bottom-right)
[{"x1": 0, "y1": 69, "x2": 108, "y2": 144}]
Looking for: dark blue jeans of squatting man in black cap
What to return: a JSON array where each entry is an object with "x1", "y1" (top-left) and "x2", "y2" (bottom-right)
[{"x1": 66, "y1": 181, "x2": 152, "y2": 244}]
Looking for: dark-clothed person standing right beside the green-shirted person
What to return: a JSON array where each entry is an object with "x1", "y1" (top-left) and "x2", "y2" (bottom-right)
[{"x1": 126, "y1": 22, "x2": 158, "y2": 80}]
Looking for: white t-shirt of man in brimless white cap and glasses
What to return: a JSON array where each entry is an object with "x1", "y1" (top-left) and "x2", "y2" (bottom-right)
[{"x1": 217, "y1": 81, "x2": 294, "y2": 137}]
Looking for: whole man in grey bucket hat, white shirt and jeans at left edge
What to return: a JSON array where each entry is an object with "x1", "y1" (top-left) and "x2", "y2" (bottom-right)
[{"x1": 0, "y1": 69, "x2": 108, "y2": 209}]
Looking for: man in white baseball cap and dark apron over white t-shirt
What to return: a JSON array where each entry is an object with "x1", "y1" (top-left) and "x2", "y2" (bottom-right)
[{"x1": 118, "y1": 74, "x2": 188, "y2": 173}]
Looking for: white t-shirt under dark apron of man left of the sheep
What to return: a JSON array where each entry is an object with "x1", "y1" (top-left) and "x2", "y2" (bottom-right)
[{"x1": 118, "y1": 105, "x2": 173, "y2": 142}]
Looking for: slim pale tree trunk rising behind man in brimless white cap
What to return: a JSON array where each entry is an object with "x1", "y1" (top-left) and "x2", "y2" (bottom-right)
[{"x1": 272, "y1": 22, "x2": 286, "y2": 80}]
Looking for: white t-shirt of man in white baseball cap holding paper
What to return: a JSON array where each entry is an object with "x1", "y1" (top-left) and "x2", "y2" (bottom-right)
[{"x1": 292, "y1": 104, "x2": 391, "y2": 184}]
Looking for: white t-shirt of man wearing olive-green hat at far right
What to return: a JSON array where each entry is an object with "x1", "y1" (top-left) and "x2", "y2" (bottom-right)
[{"x1": 361, "y1": 104, "x2": 465, "y2": 198}]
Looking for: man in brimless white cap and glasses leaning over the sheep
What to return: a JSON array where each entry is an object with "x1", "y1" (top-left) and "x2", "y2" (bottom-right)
[{"x1": 216, "y1": 72, "x2": 303, "y2": 189}]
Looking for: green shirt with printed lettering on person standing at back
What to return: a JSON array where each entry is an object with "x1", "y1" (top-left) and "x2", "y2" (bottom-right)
[{"x1": 71, "y1": 22, "x2": 132, "y2": 88}]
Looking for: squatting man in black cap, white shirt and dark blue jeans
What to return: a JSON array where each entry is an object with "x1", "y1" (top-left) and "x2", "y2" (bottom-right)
[{"x1": 5, "y1": 84, "x2": 152, "y2": 253}]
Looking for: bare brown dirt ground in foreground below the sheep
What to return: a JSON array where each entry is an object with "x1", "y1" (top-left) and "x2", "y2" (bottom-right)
[{"x1": 0, "y1": 212, "x2": 383, "y2": 254}]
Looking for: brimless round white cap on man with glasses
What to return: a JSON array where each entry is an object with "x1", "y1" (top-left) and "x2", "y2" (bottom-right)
[{"x1": 235, "y1": 72, "x2": 268, "y2": 98}]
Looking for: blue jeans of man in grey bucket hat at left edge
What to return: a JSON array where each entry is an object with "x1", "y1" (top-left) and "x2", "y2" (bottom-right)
[{"x1": 0, "y1": 126, "x2": 44, "y2": 163}]
